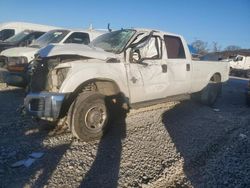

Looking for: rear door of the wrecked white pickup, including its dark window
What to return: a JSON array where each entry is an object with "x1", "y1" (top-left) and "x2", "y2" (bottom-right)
[{"x1": 164, "y1": 35, "x2": 191, "y2": 95}]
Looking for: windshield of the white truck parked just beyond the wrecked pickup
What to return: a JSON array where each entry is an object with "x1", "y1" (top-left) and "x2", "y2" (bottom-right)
[{"x1": 30, "y1": 30, "x2": 70, "y2": 48}]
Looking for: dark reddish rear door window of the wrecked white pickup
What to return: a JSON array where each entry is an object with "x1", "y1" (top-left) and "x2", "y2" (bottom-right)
[{"x1": 164, "y1": 35, "x2": 186, "y2": 59}]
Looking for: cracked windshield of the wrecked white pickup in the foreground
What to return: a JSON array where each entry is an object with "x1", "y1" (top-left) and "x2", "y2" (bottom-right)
[{"x1": 89, "y1": 29, "x2": 135, "y2": 53}]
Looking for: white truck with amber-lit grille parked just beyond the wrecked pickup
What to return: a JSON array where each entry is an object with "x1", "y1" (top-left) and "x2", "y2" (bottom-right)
[{"x1": 0, "y1": 29, "x2": 104, "y2": 87}]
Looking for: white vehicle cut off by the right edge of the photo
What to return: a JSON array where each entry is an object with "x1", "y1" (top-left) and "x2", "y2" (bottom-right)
[{"x1": 229, "y1": 55, "x2": 250, "y2": 78}]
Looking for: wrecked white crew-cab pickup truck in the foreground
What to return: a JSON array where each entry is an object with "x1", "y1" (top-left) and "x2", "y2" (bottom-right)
[{"x1": 24, "y1": 29, "x2": 229, "y2": 140}]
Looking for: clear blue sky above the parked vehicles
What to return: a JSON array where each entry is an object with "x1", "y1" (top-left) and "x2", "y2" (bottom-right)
[{"x1": 0, "y1": 0, "x2": 250, "y2": 49}]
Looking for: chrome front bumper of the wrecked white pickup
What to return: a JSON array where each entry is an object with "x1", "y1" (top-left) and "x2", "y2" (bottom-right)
[{"x1": 24, "y1": 92, "x2": 66, "y2": 120}]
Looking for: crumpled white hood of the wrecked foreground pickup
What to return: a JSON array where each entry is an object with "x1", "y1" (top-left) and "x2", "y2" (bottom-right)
[{"x1": 38, "y1": 44, "x2": 117, "y2": 60}]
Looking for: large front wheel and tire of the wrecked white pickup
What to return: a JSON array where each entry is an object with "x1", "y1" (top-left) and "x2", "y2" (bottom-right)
[{"x1": 68, "y1": 92, "x2": 109, "y2": 141}]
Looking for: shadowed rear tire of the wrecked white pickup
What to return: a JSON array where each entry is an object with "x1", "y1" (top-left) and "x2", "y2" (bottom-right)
[{"x1": 198, "y1": 75, "x2": 222, "y2": 106}]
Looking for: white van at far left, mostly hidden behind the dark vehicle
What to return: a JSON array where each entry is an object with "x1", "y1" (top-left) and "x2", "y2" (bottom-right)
[{"x1": 0, "y1": 22, "x2": 56, "y2": 41}]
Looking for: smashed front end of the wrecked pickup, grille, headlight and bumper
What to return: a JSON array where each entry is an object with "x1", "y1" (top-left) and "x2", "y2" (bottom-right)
[{"x1": 24, "y1": 56, "x2": 85, "y2": 121}]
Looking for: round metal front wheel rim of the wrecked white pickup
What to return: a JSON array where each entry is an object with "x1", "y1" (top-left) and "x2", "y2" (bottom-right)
[{"x1": 84, "y1": 104, "x2": 107, "y2": 132}]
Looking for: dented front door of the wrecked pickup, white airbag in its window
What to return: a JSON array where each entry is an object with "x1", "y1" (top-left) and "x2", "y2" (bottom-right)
[{"x1": 126, "y1": 36, "x2": 169, "y2": 103}]
